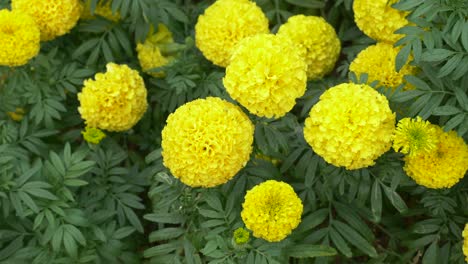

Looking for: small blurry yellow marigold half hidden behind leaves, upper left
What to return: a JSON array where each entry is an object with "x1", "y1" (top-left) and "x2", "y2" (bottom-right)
[{"x1": 136, "y1": 24, "x2": 174, "y2": 77}]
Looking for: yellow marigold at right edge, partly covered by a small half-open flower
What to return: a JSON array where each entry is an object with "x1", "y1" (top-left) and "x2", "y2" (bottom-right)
[{"x1": 403, "y1": 125, "x2": 468, "y2": 189}]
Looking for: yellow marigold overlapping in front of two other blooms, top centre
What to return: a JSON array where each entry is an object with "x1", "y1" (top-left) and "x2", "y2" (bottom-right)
[{"x1": 223, "y1": 34, "x2": 307, "y2": 118}]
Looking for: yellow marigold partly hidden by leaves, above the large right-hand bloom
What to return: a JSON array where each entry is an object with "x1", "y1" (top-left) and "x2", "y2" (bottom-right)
[{"x1": 349, "y1": 43, "x2": 416, "y2": 90}]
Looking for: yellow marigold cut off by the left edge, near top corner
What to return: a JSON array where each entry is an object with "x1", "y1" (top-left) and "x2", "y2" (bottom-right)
[{"x1": 0, "y1": 9, "x2": 41, "y2": 67}]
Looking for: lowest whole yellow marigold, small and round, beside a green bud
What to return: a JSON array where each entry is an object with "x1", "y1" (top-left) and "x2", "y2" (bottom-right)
[{"x1": 241, "y1": 180, "x2": 303, "y2": 242}]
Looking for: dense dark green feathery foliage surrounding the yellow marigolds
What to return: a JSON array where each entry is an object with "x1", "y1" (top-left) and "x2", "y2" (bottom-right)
[{"x1": 0, "y1": 0, "x2": 468, "y2": 264}]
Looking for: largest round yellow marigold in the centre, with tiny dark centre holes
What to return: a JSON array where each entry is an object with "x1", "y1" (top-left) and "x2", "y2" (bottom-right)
[{"x1": 161, "y1": 97, "x2": 254, "y2": 187}]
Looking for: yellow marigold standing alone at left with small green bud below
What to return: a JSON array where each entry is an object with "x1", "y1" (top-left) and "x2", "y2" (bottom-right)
[{"x1": 78, "y1": 63, "x2": 148, "y2": 131}]
